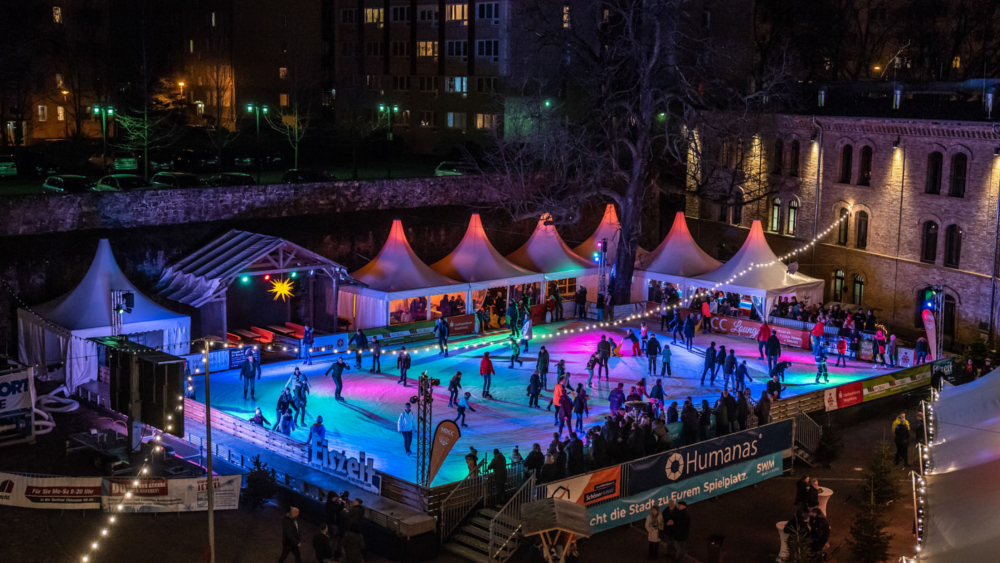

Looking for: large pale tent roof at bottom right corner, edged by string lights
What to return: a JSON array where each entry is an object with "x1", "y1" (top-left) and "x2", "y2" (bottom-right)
[{"x1": 911, "y1": 370, "x2": 1000, "y2": 563}]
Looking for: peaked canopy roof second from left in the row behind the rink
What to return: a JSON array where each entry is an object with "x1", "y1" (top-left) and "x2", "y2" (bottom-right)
[{"x1": 431, "y1": 213, "x2": 544, "y2": 289}]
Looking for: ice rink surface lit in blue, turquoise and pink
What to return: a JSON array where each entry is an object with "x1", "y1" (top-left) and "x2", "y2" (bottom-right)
[{"x1": 189, "y1": 316, "x2": 885, "y2": 484}]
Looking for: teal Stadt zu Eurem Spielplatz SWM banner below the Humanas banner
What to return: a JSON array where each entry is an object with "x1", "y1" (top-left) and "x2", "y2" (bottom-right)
[{"x1": 584, "y1": 454, "x2": 790, "y2": 534}]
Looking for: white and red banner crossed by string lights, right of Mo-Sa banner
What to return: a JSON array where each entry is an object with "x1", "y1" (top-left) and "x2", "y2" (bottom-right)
[{"x1": 101, "y1": 475, "x2": 242, "y2": 512}]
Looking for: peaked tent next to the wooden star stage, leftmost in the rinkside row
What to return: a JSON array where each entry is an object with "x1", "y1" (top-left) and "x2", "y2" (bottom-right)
[{"x1": 338, "y1": 219, "x2": 460, "y2": 328}]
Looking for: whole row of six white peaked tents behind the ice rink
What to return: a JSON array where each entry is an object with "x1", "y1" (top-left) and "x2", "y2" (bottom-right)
[{"x1": 338, "y1": 205, "x2": 823, "y2": 328}]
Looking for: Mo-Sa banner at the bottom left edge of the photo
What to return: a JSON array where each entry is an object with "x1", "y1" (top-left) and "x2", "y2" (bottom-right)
[{"x1": 0, "y1": 473, "x2": 101, "y2": 510}]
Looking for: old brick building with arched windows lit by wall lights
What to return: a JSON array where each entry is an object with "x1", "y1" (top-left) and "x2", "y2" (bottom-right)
[{"x1": 687, "y1": 115, "x2": 1000, "y2": 348}]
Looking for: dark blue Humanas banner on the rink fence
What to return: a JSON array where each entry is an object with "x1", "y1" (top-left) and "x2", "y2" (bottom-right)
[{"x1": 628, "y1": 420, "x2": 792, "y2": 495}]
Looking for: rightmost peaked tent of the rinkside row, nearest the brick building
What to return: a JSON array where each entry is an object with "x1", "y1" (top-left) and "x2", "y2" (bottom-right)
[{"x1": 691, "y1": 220, "x2": 823, "y2": 318}]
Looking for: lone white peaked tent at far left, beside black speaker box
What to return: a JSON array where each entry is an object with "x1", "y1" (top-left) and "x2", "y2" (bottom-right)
[{"x1": 17, "y1": 239, "x2": 191, "y2": 392}]
